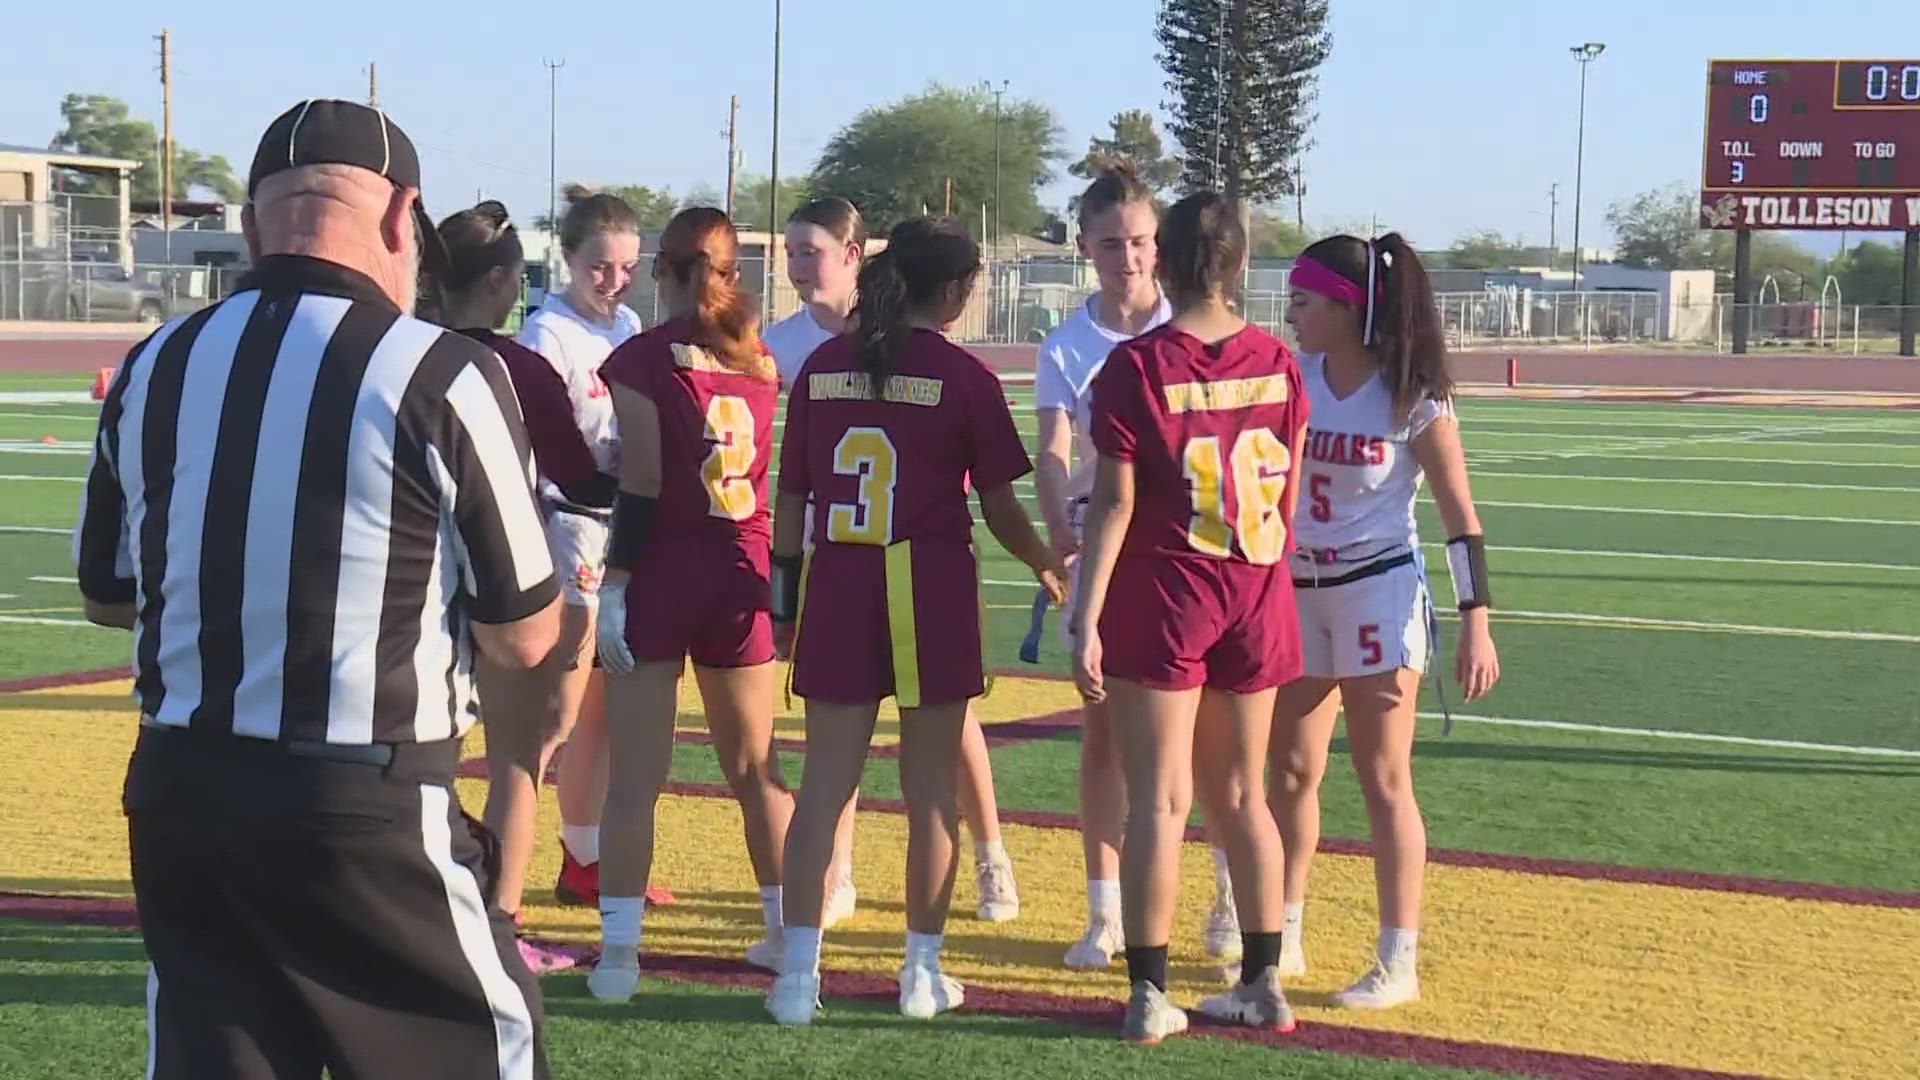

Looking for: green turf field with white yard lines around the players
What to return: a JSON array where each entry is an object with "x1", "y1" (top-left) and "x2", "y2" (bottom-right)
[{"x1": 0, "y1": 365, "x2": 1920, "y2": 1078}]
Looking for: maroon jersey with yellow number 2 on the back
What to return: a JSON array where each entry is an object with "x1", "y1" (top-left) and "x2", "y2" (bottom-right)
[{"x1": 599, "y1": 319, "x2": 780, "y2": 540}]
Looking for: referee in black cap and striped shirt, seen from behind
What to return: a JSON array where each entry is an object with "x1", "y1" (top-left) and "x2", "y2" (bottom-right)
[{"x1": 75, "y1": 100, "x2": 559, "y2": 1080}]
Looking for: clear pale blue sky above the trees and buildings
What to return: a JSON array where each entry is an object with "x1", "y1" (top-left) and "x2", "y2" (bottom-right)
[{"x1": 0, "y1": 0, "x2": 1920, "y2": 246}]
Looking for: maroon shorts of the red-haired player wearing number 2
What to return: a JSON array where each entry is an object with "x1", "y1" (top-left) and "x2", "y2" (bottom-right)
[{"x1": 626, "y1": 538, "x2": 774, "y2": 667}]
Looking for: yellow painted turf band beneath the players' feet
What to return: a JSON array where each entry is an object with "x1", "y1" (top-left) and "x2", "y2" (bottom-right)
[{"x1": 0, "y1": 684, "x2": 1920, "y2": 1076}]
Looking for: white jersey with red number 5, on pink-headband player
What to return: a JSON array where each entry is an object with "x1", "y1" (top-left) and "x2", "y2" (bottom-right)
[{"x1": 1294, "y1": 354, "x2": 1453, "y2": 563}]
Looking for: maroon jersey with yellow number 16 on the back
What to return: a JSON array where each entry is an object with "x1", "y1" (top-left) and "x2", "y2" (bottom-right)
[{"x1": 1092, "y1": 325, "x2": 1308, "y2": 567}]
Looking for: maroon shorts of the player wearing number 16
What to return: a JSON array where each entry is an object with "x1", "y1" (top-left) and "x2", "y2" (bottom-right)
[{"x1": 1100, "y1": 555, "x2": 1300, "y2": 694}]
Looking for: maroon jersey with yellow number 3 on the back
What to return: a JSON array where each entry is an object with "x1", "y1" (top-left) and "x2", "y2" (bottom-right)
[{"x1": 780, "y1": 331, "x2": 1033, "y2": 546}]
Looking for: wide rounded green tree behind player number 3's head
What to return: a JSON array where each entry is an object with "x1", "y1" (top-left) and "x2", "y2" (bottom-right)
[{"x1": 812, "y1": 83, "x2": 1066, "y2": 236}]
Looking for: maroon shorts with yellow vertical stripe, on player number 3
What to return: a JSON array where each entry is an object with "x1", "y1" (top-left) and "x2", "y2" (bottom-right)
[{"x1": 793, "y1": 540, "x2": 987, "y2": 709}]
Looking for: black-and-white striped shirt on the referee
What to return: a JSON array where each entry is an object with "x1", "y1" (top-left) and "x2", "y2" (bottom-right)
[{"x1": 75, "y1": 256, "x2": 559, "y2": 744}]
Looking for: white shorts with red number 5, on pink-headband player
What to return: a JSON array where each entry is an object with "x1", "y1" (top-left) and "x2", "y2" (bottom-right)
[{"x1": 1290, "y1": 559, "x2": 1428, "y2": 678}]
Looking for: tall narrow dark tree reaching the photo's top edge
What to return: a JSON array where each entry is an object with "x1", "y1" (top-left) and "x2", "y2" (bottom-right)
[{"x1": 1154, "y1": 0, "x2": 1332, "y2": 202}]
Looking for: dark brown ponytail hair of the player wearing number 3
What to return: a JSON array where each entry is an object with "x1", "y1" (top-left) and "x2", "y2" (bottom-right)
[{"x1": 852, "y1": 217, "x2": 979, "y2": 400}]
